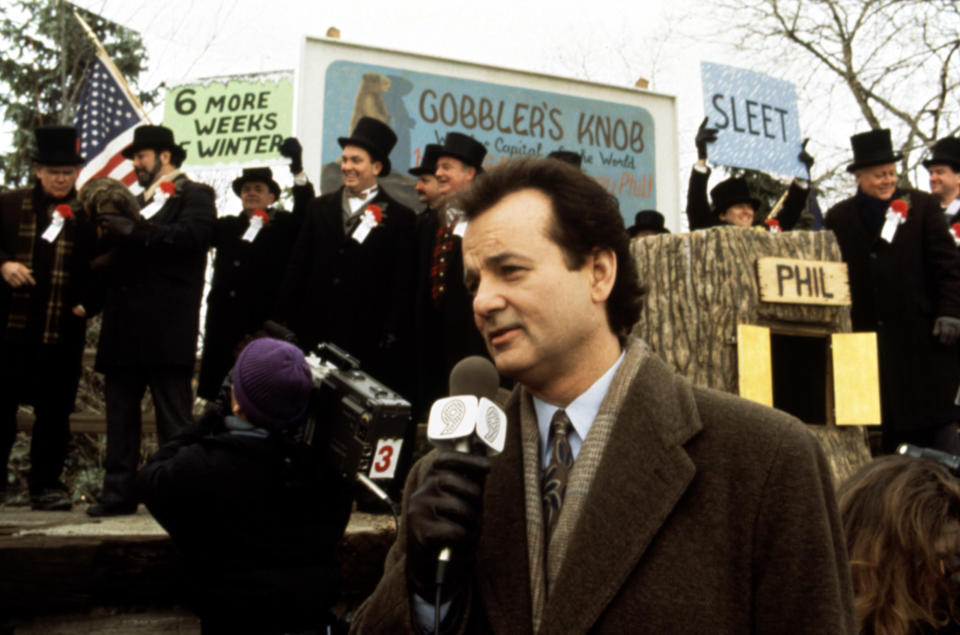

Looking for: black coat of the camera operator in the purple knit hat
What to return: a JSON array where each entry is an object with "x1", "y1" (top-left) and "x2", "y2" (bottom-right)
[{"x1": 137, "y1": 415, "x2": 352, "y2": 633}]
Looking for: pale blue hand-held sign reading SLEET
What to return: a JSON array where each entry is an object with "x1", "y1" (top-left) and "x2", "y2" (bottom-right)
[{"x1": 700, "y1": 62, "x2": 807, "y2": 178}]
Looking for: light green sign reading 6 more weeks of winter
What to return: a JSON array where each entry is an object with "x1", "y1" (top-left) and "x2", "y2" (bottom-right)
[{"x1": 163, "y1": 73, "x2": 293, "y2": 165}]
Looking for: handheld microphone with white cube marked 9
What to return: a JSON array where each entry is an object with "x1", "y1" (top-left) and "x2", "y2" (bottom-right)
[{"x1": 427, "y1": 355, "x2": 507, "y2": 583}]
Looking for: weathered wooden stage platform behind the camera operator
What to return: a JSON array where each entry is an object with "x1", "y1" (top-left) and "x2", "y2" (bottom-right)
[{"x1": 0, "y1": 505, "x2": 394, "y2": 626}]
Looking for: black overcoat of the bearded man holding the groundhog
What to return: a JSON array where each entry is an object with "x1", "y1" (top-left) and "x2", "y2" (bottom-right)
[{"x1": 96, "y1": 177, "x2": 217, "y2": 372}]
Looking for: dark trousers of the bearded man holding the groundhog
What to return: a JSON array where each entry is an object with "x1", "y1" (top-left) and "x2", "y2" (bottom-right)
[{"x1": 100, "y1": 366, "x2": 193, "y2": 506}]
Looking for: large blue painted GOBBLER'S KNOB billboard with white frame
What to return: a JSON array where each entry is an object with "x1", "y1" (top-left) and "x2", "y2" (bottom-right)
[{"x1": 297, "y1": 38, "x2": 679, "y2": 228}]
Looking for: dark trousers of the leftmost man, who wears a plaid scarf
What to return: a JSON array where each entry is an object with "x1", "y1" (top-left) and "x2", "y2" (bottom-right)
[{"x1": 0, "y1": 346, "x2": 80, "y2": 494}]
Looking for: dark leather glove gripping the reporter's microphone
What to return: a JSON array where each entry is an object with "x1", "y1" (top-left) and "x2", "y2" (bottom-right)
[{"x1": 406, "y1": 451, "x2": 490, "y2": 602}]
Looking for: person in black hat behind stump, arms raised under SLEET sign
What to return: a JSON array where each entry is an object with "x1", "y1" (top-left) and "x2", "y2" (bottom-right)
[{"x1": 687, "y1": 118, "x2": 813, "y2": 231}]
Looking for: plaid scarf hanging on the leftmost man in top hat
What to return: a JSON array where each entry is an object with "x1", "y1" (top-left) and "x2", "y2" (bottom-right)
[{"x1": 6, "y1": 194, "x2": 73, "y2": 344}]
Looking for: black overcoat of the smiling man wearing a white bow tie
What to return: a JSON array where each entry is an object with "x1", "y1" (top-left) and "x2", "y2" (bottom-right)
[{"x1": 275, "y1": 187, "x2": 415, "y2": 398}]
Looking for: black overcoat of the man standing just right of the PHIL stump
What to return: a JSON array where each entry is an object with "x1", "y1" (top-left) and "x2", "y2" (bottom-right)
[{"x1": 825, "y1": 190, "x2": 960, "y2": 431}]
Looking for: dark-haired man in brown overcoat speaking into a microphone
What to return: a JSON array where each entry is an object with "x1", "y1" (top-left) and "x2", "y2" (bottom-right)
[{"x1": 352, "y1": 159, "x2": 855, "y2": 634}]
